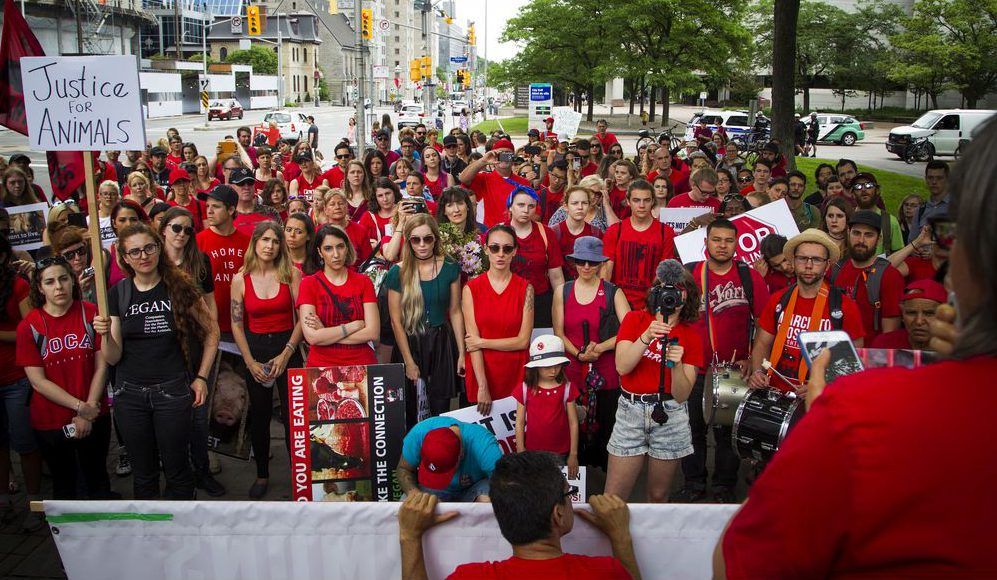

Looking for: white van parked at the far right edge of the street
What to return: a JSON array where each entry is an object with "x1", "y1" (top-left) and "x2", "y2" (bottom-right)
[{"x1": 886, "y1": 109, "x2": 997, "y2": 156}]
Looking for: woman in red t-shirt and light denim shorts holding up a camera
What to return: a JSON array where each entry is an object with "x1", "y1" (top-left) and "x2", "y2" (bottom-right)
[{"x1": 606, "y1": 260, "x2": 705, "y2": 503}]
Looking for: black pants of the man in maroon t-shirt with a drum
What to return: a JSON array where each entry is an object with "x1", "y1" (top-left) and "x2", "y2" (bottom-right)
[{"x1": 682, "y1": 375, "x2": 741, "y2": 490}]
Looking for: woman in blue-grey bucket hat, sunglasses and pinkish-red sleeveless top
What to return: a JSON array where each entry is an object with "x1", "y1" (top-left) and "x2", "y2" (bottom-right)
[{"x1": 553, "y1": 236, "x2": 630, "y2": 470}]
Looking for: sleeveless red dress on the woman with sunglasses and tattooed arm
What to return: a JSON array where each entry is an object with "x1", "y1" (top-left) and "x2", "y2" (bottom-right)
[{"x1": 465, "y1": 273, "x2": 529, "y2": 403}]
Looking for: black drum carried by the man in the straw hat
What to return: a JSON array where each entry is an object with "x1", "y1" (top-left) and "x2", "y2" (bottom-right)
[{"x1": 731, "y1": 389, "x2": 805, "y2": 462}]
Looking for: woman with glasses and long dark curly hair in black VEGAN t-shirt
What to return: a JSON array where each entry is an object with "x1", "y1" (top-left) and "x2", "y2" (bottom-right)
[{"x1": 93, "y1": 224, "x2": 218, "y2": 500}]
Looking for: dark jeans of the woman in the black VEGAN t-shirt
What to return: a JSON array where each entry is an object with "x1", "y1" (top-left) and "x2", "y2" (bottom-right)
[{"x1": 114, "y1": 376, "x2": 194, "y2": 500}]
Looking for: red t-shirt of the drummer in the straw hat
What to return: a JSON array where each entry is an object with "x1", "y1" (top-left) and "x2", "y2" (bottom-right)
[{"x1": 758, "y1": 288, "x2": 865, "y2": 391}]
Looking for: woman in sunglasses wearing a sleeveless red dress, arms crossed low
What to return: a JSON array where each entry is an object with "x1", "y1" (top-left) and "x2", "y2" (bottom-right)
[{"x1": 461, "y1": 225, "x2": 534, "y2": 415}]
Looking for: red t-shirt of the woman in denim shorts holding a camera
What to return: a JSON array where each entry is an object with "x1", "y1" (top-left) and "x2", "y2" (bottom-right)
[{"x1": 616, "y1": 307, "x2": 706, "y2": 395}]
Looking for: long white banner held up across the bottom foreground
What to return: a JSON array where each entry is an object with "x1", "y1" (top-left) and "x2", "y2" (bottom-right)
[{"x1": 44, "y1": 501, "x2": 737, "y2": 580}]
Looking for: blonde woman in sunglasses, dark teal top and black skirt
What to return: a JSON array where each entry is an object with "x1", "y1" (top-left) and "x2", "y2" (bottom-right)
[{"x1": 384, "y1": 214, "x2": 464, "y2": 429}]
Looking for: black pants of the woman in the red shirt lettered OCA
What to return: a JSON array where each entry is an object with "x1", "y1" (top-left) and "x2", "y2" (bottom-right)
[{"x1": 35, "y1": 415, "x2": 111, "y2": 499}]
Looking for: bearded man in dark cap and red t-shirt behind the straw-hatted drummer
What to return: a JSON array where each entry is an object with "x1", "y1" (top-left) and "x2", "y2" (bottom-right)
[{"x1": 830, "y1": 210, "x2": 904, "y2": 342}]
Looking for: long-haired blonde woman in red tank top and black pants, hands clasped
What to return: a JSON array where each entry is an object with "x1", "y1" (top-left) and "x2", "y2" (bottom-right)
[{"x1": 232, "y1": 221, "x2": 302, "y2": 499}]
